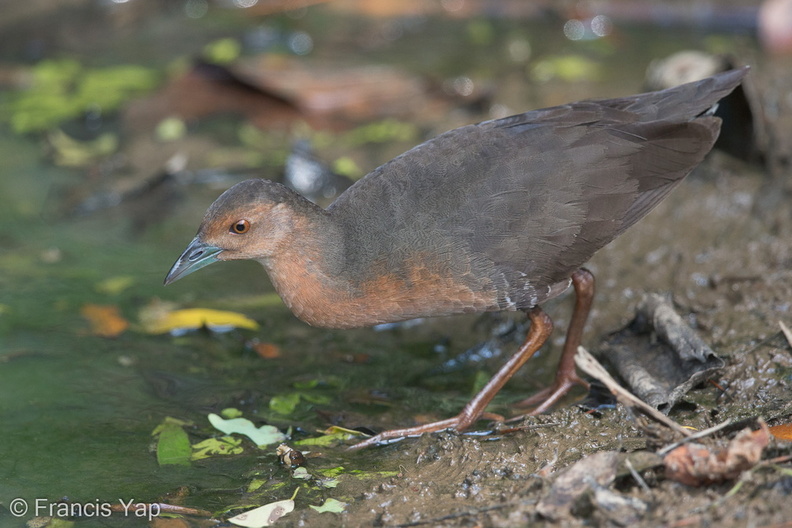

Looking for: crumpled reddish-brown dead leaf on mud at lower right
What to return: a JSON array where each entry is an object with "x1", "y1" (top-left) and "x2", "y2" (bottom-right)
[{"x1": 663, "y1": 422, "x2": 770, "y2": 486}]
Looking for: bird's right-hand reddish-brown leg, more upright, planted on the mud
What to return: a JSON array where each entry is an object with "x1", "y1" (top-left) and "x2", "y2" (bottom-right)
[{"x1": 517, "y1": 268, "x2": 594, "y2": 415}]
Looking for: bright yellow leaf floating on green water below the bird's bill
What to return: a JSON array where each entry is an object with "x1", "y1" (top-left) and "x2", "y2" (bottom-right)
[{"x1": 141, "y1": 308, "x2": 259, "y2": 335}]
